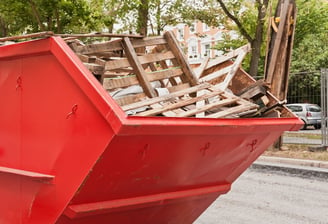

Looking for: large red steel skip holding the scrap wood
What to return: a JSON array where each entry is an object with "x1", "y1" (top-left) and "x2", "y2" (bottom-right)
[{"x1": 0, "y1": 37, "x2": 302, "y2": 224}]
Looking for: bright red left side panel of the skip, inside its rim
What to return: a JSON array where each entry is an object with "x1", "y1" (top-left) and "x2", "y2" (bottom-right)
[{"x1": 0, "y1": 49, "x2": 114, "y2": 224}]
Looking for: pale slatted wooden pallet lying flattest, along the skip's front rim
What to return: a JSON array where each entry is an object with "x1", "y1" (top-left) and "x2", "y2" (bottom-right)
[{"x1": 122, "y1": 83, "x2": 258, "y2": 118}]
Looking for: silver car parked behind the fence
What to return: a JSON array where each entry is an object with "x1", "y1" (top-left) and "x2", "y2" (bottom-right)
[{"x1": 286, "y1": 103, "x2": 321, "y2": 129}]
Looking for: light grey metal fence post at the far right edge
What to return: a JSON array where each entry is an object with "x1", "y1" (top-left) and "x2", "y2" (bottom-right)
[{"x1": 321, "y1": 69, "x2": 328, "y2": 150}]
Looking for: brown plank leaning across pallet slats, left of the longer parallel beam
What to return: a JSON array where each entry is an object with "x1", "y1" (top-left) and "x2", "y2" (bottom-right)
[{"x1": 123, "y1": 37, "x2": 156, "y2": 97}]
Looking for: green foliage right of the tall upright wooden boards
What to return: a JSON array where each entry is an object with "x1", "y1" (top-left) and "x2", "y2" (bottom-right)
[{"x1": 291, "y1": 0, "x2": 328, "y2": 72}]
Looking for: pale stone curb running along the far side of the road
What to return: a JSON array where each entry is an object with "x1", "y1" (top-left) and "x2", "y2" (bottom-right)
[{"x1": 250, "y1": 156, "x2": 328, "y2": 181}]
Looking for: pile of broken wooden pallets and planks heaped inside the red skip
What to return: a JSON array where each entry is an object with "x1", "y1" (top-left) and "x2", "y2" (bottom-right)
[{"x1": 67, "y1": 32, "x2": 282, "y2": 118}]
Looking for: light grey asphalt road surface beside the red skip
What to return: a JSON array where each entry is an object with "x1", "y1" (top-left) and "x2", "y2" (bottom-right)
[{"x1": 194, "y1": 169, "x2": 328, "y2": 224}]
